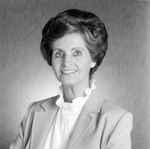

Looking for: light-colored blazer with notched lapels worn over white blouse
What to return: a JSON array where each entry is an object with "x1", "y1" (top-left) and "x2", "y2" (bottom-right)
[{"x1": 10, "y1": 89, "x2": 133, "y2": 149}]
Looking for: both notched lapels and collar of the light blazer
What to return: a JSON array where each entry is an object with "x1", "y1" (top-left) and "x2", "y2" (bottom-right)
[{"x1": 31, "y1": 88, "x2": 103, "y2": 149}]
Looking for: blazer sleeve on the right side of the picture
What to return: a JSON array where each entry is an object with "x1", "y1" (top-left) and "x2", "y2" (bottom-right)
[{"x1": 106, "y1": 112, "x2": 133, "y2": 149}]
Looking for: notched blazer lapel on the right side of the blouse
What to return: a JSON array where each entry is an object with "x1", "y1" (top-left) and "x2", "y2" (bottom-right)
[{"x1": 67, "y1": 89, "x2": 104, "y2": 149}]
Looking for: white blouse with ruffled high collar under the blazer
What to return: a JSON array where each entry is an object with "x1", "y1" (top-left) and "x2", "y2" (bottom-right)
[{"x1": 43, "y1": 80, "x2": 96, "y2": 149}]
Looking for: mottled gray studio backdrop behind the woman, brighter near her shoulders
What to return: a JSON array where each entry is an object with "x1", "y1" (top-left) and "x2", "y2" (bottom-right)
[{"x1": 0, "y1": 0, "x2": 150, "y2": 149}]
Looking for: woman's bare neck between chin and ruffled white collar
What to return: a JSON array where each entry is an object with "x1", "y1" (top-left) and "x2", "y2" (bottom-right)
[{"x1": 63, "y1": 82, "x2": 89, "y2": 103}]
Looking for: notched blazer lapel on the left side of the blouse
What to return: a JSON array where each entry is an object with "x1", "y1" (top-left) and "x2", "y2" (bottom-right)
[{"x1": 31, "y1": 96, "x2": 59, "y2": 149}]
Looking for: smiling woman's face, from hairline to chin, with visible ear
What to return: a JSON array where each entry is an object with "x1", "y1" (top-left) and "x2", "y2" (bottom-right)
[{"x1": 52, "y1": 33, "x2": 95, "y2": 86}]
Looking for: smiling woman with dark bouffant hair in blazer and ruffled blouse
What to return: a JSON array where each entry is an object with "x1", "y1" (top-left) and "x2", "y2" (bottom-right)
[{"x1": 10, "y1": 9, "x2": 132, "y2": 149}]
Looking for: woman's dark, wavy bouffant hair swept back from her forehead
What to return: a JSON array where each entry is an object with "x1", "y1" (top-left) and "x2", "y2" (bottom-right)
[{"x1": 40, "y1": 9, "x2": 108, "y2": 80}]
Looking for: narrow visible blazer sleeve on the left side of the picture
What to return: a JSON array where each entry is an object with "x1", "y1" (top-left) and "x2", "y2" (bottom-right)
[{"x1": 9, "y1": 103, "x2": 34, "y2": 149}]
